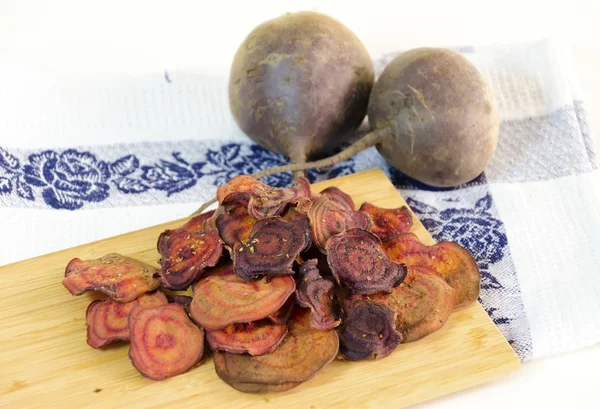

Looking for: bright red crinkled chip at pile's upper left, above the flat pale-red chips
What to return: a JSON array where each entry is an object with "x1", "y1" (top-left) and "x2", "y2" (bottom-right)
[{"x1": 158, "y1": 229, "x2": 223, "y2": 290}]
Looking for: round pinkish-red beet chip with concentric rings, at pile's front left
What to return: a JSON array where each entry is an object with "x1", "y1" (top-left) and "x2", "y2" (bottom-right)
[{"x1": 129, "y1": 304, "x2": 204, "y2": 380}]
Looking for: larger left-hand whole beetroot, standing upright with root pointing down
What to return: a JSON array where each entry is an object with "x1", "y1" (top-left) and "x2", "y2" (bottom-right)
[{"x1": 229, "y1": 12, "x2": 374, "y2": 174}]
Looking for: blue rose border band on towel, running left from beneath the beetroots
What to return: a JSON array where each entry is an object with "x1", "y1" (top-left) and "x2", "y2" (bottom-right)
[{"x1": 0, "y1": 143, "x2": 354, "y2": 210}]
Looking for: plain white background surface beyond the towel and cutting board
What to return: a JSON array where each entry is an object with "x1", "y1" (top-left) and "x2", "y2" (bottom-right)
[{"x1": 0, "y1": 0, "x2": 600, "y2": 408}]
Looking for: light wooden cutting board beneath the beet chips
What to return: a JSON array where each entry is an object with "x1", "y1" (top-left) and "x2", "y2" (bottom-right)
[{"x1": 0, "y1": 170, "x2": 519, "y2": 409}]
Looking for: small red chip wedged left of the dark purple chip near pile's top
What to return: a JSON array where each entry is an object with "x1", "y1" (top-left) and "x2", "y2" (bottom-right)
[{"x1": 215, "y1": 200, "x2": 256, "y2": 249}]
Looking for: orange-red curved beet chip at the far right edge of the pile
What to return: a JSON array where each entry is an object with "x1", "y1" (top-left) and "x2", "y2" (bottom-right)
[{"x1": 383, "y1": 233, "x2": 481, "y2": 307}]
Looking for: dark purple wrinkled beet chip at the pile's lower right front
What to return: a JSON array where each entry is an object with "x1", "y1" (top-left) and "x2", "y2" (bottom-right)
[{"x1": 338, "y1": 300, "x2": 402, "y2": 361}]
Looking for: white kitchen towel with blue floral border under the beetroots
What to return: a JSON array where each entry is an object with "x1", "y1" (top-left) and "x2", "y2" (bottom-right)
[{"x1": 0, "y1": 41, "x2": 600, "y2": 361}]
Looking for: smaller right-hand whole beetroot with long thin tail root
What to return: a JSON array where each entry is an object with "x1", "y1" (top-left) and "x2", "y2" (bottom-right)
[{"x1": 253, "y1": 48, "x2": 499, "y2": 187}]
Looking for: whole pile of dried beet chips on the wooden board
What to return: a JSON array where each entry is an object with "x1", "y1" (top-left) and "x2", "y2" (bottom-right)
[{"x1": 63, "y1": 176, "x2": 480, "y2": 392}]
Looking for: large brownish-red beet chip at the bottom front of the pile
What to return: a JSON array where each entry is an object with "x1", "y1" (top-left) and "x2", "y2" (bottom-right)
[{"x1": 214, "y1": 308, "x2": 339, "y2": 392}]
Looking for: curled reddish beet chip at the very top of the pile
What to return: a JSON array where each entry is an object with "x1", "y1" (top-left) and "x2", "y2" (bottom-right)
[{"x1": 217, "y1": 175, "x2": 310, "y2": 220}]
